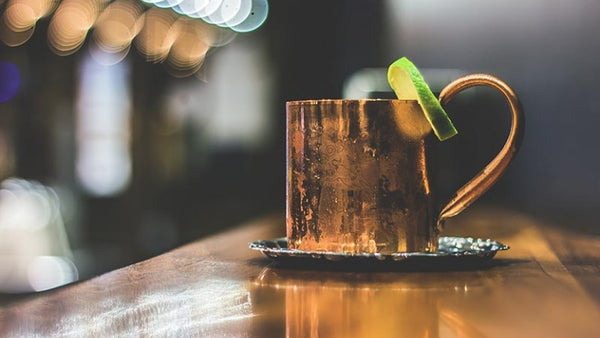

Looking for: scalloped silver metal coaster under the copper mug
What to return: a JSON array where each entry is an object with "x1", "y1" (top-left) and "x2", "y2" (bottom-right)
[{"x1": 249, "y1": 237, "x2": 509, "y2": 270}]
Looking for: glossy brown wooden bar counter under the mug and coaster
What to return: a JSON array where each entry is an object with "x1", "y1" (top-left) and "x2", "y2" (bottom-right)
[{"x1": 0, "y1": 208, "x2": 600, "y2": 337}]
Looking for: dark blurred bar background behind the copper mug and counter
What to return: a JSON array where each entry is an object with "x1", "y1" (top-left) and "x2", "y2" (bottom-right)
[{"x1": 0, "y1": 0, "x2": 600, "y2": 290}]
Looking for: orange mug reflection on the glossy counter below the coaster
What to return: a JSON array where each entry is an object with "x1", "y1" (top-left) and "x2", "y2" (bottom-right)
[{"x1": 252, "y1": 268, "x2": 483, "y2": 337}]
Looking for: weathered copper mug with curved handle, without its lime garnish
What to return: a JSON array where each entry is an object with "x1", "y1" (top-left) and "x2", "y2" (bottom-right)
[{"x1": 286, "y1": 74, "x2": 524, "y2": 254}]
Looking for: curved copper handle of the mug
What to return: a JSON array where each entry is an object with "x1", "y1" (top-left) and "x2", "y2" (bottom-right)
[{"x1": 438, "y1": 74, "x2": 525, "y2": 226}]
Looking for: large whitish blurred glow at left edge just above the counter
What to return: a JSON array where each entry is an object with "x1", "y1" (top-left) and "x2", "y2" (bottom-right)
[{"x1": 0, "y1": 177, "x2": 78, "y2": 293}]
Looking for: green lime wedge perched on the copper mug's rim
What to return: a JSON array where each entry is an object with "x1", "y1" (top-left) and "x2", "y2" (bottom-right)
[{"x1": 388, "y1": 57, "x2": 458, "y2": 141}]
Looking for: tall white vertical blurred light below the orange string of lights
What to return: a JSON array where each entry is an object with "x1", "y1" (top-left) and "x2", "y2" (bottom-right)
[{"x1": 75, "y1": 54, "x2": 132, "y2": 197}]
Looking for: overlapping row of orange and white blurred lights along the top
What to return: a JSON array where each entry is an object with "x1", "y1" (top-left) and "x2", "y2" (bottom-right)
[{"x1": 0, "y1": 0, "x2": 269, "y2": 76}]
